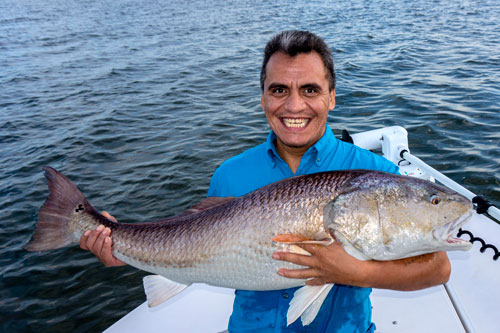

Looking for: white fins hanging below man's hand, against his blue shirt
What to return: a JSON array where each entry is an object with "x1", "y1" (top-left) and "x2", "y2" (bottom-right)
[{"x1": 286, "y1": 284, "x2": 333, "y2": 326}]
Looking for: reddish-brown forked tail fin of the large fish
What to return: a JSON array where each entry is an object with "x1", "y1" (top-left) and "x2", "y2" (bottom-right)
[{"x1": 24, "y1": 167, "x2": 95, "y2": 251}]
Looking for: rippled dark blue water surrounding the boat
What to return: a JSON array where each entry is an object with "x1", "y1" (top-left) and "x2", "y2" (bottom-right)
[{"x1": 0, "y1": 0, "x2": 500, "y2": 332}]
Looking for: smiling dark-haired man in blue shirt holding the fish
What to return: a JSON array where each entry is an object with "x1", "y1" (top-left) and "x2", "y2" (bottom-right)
[{"x1": 81, "y1": 31, "x2": 450, "y2": 332}]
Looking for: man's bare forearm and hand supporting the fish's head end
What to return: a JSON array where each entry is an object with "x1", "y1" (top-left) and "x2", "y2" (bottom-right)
[{"x1": 273, "y1": 242, "x2": 451, "y2": 291}]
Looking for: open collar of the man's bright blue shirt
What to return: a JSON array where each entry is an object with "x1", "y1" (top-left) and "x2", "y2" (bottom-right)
[{"x1": 265, "y1": 125, "x2": 338, "y2": 167}]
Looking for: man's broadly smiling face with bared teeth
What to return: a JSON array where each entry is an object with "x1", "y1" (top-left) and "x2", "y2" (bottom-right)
[{"x1": 261, "y1": 51, "x2": 335, "y2": 151}]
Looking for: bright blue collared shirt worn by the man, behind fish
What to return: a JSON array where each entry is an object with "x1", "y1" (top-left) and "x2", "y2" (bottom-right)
[{"x1": 208, "y1": 126, "x2": 398, "y2": 332}]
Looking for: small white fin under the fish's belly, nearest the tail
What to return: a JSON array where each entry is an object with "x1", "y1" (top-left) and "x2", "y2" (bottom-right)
[{"x1": 142, "y1": 275, "x2": 188, "y2": 308}]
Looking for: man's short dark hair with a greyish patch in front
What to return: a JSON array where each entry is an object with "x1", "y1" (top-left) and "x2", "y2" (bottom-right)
[{"x1": 260, "y1": 30, "x2": 335, "y2": 91}]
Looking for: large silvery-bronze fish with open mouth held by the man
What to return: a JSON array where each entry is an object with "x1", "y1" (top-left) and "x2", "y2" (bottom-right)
[{"x1": 25, "y1": 167, "x2": 472, "y2": 324}]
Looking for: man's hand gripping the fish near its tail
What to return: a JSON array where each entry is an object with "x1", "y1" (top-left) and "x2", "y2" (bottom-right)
[{"x1": 80, "y1": 212, "x2": 126, "y2": 267}]
